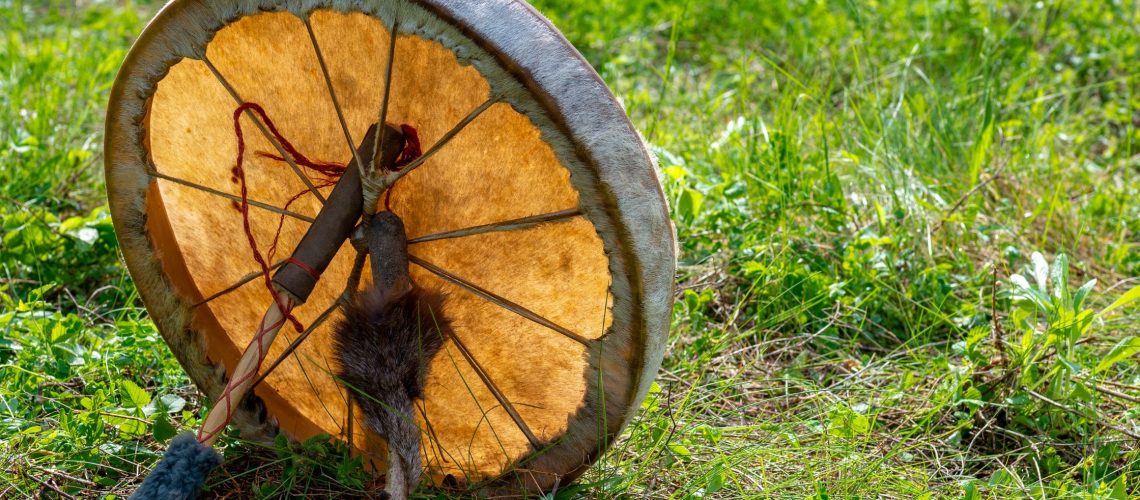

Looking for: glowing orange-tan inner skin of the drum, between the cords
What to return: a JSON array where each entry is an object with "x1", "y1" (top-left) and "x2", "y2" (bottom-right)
[{"x1": 148, "y1": 11, "x2": 612, "y2": 477}]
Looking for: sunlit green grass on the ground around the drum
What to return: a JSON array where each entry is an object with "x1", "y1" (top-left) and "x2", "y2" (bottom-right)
[{"x1": 0, "y1": 0, "x2": 1140, "y2": 499}]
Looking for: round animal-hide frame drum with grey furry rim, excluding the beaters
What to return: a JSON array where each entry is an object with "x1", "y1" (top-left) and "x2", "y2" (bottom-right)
[{"x1": 106, "y1": 0, "x2": 675, "y2": 491}]
